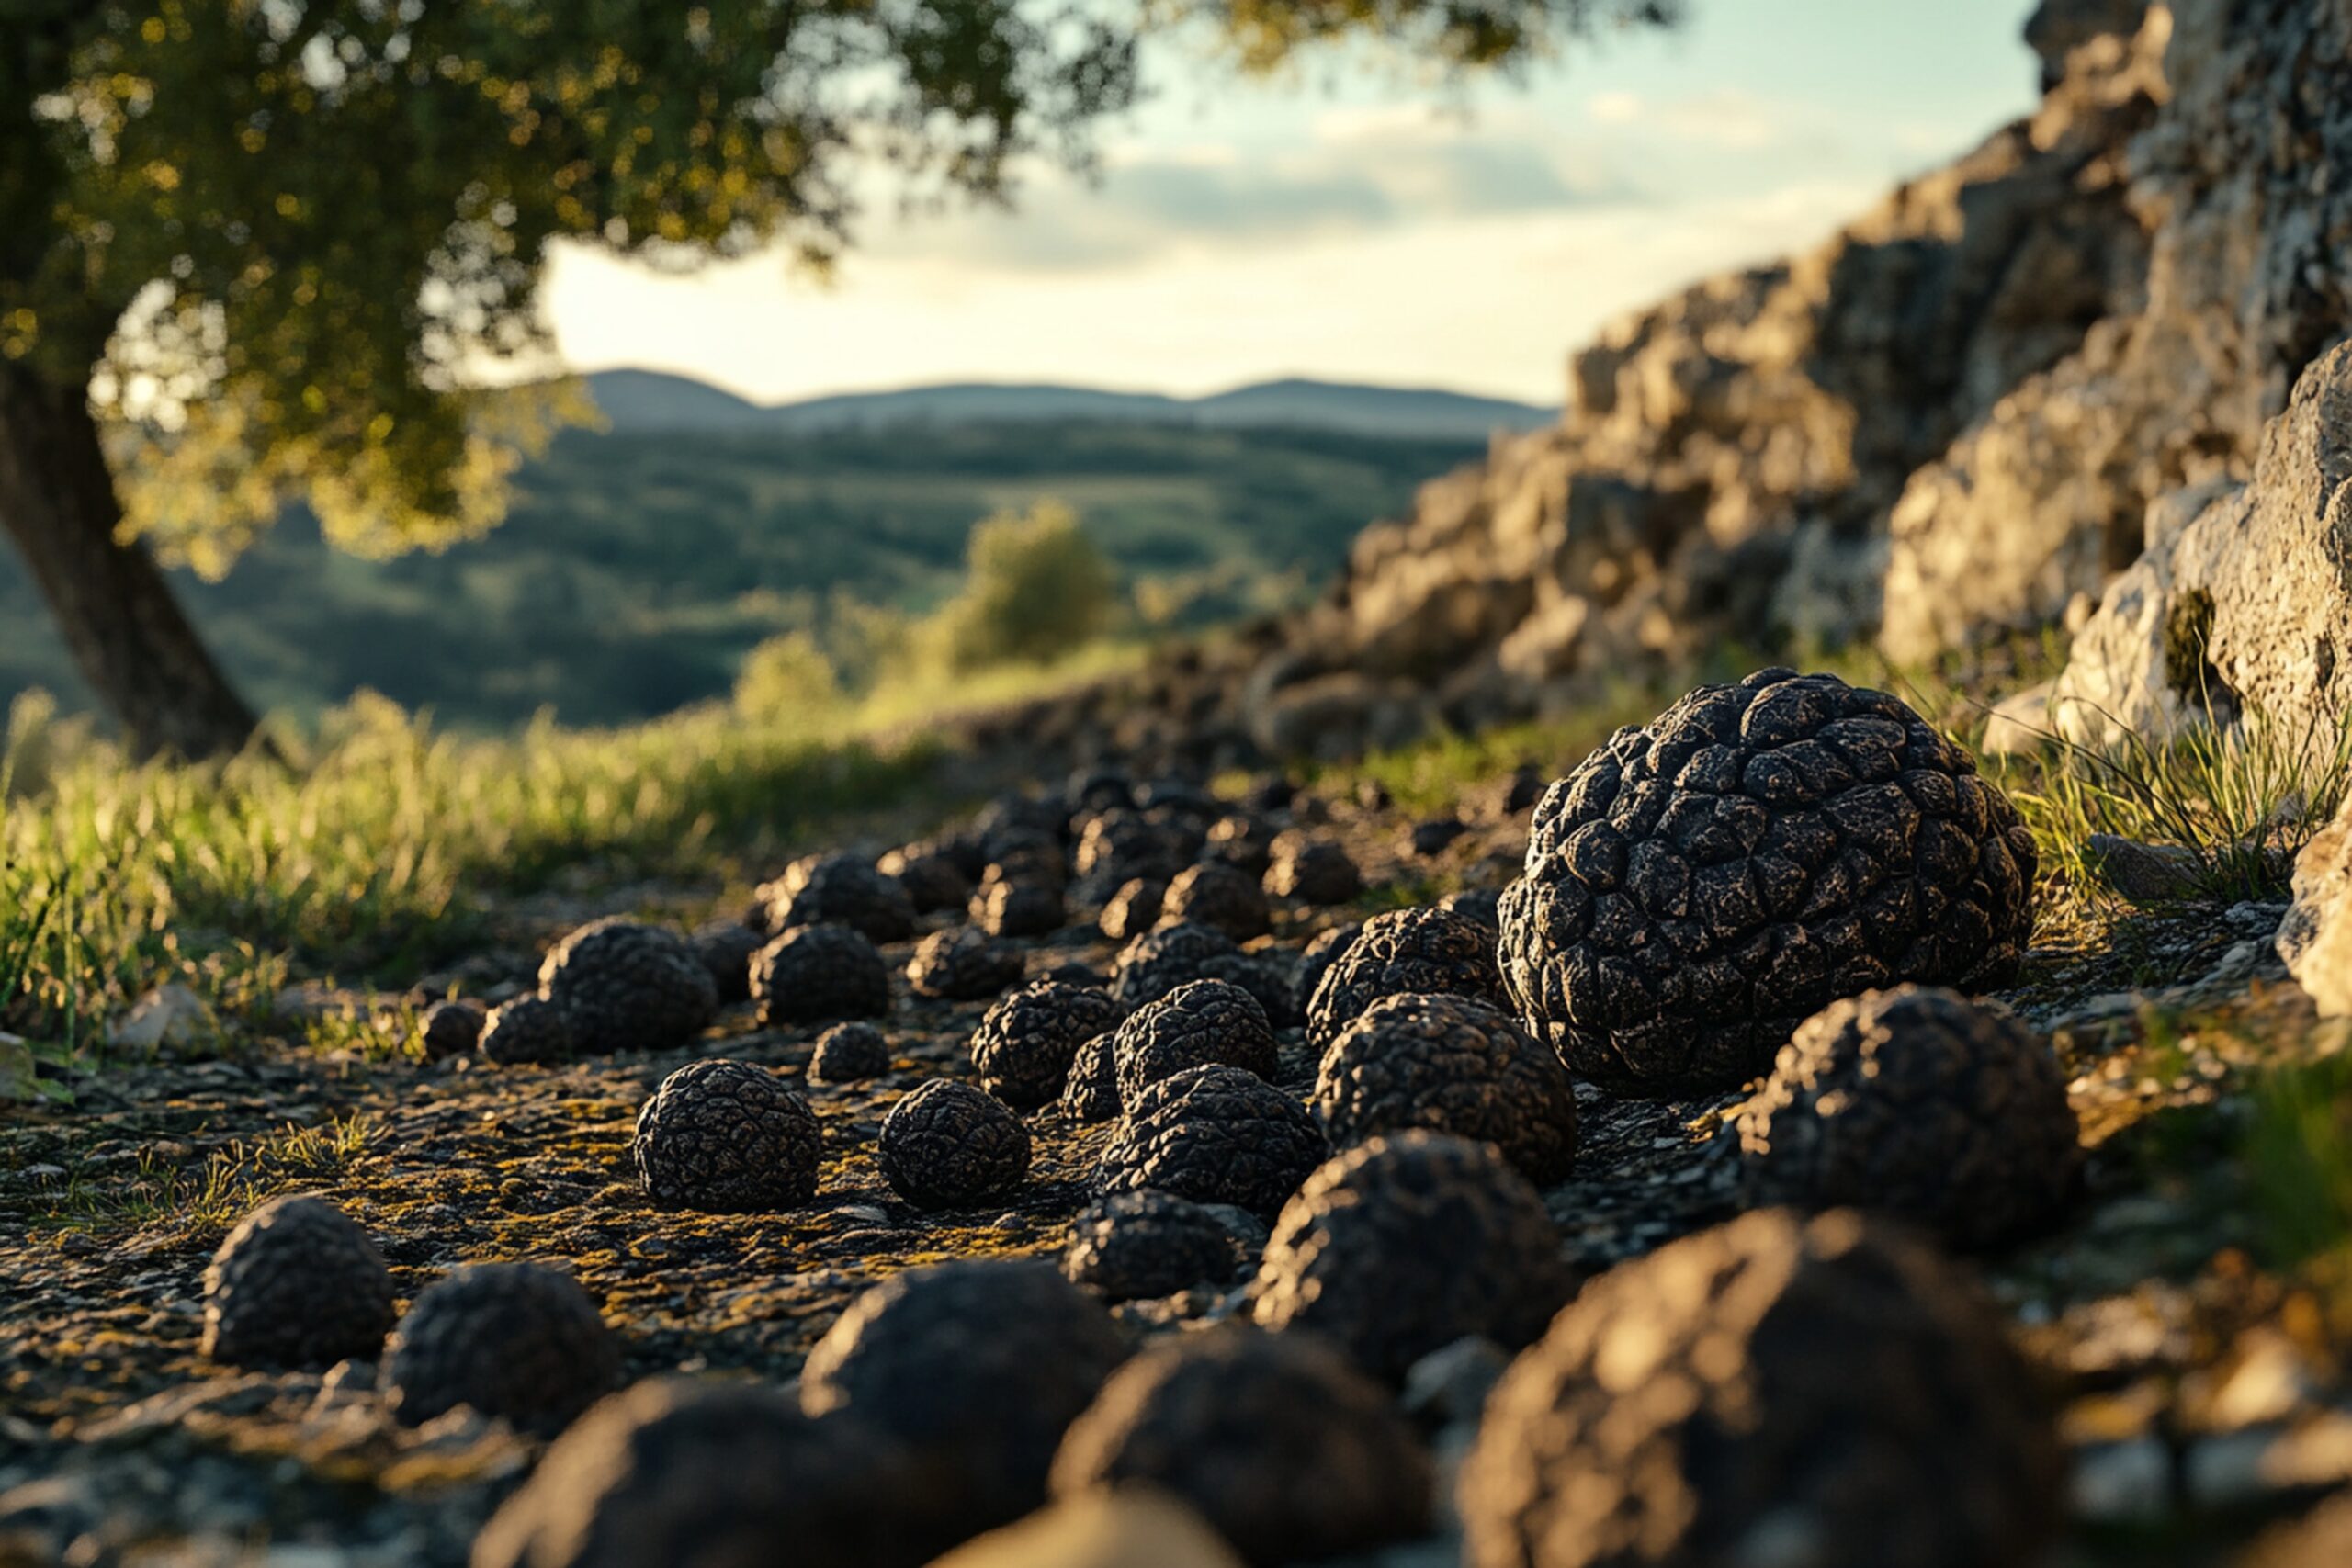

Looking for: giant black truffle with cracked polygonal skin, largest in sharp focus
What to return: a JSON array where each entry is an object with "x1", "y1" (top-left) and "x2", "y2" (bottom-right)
[{"x1": 1500, "y1": 670, "x2": 2034, "y2": 1093}]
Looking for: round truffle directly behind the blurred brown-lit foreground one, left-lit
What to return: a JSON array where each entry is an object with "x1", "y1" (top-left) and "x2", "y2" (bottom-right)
[{"x1": 1251, "y1": 1134, "x2": 1574, "y2": 1382}]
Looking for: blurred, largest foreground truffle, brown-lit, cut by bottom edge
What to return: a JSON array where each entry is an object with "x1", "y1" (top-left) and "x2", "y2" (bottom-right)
[{"x1": 1461, "y1": 1208, "x2": 2065, "y2": 1568}]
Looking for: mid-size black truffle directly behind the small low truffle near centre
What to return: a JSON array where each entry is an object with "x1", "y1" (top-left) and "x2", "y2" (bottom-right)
[{"x1": 1099, "y1": 1063, "x2": 1331, "y2": 1215}]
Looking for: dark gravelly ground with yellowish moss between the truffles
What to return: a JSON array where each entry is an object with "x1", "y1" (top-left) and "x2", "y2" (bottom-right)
[{"x1": 0, "y1": 747, "x2": 2352, "y2": 1568}]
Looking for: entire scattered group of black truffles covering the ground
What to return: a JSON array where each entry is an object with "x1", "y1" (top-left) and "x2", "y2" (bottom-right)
[{"x1": 205, "y1": 670, "x2": 2117, "y2": 1568}]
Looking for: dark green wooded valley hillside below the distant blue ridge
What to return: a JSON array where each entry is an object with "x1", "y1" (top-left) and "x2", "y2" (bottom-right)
[{"x1": 0, "y1": 423, "x2": 1479, "y2": 727}]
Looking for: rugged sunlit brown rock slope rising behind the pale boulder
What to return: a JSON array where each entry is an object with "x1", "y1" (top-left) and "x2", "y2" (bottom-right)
[{"x1": 1239, "y1": 0, "x2": 2352, "y2": 752}]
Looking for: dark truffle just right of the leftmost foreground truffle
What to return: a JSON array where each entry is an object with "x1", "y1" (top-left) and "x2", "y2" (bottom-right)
[{"x1": 383, "y1": 1262, "x2": 621, "y2": 1437}]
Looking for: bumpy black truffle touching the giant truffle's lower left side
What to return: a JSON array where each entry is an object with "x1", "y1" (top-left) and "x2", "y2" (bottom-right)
[{"x1": 1315, "y1": 995, "x2": 1576, "y2": 1182}]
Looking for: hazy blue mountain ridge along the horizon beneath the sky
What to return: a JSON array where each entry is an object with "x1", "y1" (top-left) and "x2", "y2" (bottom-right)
[{"x1": 583, "y1": 369, "x2": 1559, "y2": 440}]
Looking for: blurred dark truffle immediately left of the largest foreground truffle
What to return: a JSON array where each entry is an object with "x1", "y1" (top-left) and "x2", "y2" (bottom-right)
[{"x1": 1054, "y1": 1324, "x2": 1432, "y2": 1568}]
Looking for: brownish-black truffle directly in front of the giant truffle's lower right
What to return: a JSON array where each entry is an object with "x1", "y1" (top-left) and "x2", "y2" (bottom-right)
[{"x1": 1738, "y1": 985, "x2": 2082, "y2": 1248}]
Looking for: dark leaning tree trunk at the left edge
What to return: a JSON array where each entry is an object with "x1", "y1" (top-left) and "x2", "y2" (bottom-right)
[{"x1": 0, "y1": 365, "x2": 254, "y2": 757}]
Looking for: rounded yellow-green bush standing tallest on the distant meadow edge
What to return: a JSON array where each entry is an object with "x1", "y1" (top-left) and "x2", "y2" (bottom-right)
[{"x1": 938, "y1": 501, "x2": 1117, "y2": 670}]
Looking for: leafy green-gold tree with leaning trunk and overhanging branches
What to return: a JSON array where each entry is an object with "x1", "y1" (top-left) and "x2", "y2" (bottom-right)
[{"x1": 0, "y1": 0, "x2": 1672, "y2": 755}]
